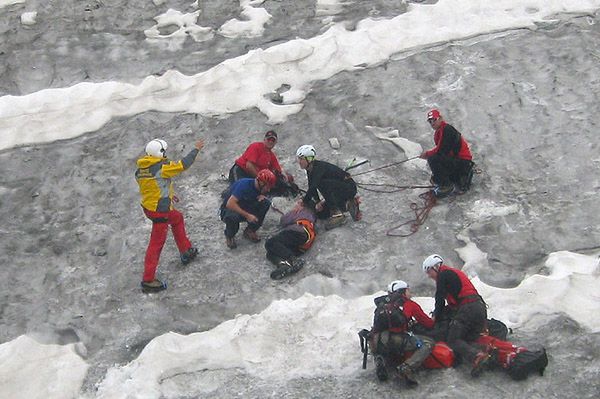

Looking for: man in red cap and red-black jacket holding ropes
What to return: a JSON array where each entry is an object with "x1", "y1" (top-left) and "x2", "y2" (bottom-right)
[{"x1": 420, "y1": 109, "x2": 473, "y2": 198}]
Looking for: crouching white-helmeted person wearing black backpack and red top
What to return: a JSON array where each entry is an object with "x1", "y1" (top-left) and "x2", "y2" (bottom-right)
[{"x1": 370, "y1": 280, "x2": 435, "y2": 387}]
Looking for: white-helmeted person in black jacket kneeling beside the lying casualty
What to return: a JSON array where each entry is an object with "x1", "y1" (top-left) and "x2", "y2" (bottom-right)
[{"x1": 296, "y1": 145, "x2": 361, "y2": 230}]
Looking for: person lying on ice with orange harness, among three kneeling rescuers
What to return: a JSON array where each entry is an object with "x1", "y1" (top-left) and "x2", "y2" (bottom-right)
[{"x1": 265, "y1": 201, "x2": 317, "y2": 280}]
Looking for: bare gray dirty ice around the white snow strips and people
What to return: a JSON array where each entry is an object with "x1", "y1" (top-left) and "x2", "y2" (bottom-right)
[{"x1": 0, "y1": 0, "x2": 600, "y2": 398}]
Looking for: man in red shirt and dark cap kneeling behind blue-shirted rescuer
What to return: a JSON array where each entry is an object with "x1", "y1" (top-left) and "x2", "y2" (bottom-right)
[{"x1": 229, "y1": 130, "x2": 300, "y2": 197}]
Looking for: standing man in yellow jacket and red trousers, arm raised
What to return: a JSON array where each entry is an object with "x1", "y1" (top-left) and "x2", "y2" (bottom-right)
[{"x1": 135, "y1": 139, "x2": 204, "y2": 293}]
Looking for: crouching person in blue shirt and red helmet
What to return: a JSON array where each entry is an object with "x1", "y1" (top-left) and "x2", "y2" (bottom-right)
[{"x1": 220, "y1": 169, "x2": 275, "y2": 249}]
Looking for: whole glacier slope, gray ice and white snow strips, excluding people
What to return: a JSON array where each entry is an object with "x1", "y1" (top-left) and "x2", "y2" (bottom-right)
[{"x1": 0, "y1": 0, "x2": 600, "y2": 398}]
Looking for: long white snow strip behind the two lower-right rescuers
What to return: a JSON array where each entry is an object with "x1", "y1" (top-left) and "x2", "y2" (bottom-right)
[{"x1": 98, "y1": 252, "x2": 600, "y2": 399}]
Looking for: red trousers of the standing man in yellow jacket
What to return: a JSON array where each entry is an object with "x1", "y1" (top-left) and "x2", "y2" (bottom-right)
[{"x1": 143, "y1": 208, "x2": 192, "y2": 281}]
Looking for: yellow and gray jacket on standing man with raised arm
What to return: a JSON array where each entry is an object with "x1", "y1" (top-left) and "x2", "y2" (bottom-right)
[{"x1": 135, "y1": 148, "x2": 198, "y2": 212}]
